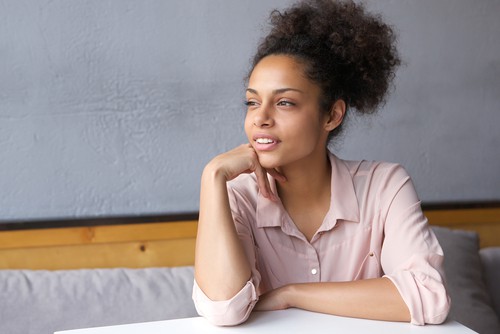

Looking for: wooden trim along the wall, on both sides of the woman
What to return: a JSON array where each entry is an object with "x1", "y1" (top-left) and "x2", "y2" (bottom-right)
[{"x1": 0, "y1": 205, "x2": 500, "y2": 270}]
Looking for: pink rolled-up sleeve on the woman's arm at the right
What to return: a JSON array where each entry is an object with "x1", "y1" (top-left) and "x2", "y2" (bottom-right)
[{"x1": 382, "y1": 166, "x2": 450, "y2": 325}]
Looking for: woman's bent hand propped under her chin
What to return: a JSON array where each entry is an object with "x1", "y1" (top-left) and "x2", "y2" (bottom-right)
[{"x1": 205, "y1": 144, "x2": 286, "y2": 201}]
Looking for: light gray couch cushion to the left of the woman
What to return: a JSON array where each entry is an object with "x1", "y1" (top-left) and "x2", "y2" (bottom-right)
[{"x1": 0, "y1": 267, "x2": 197, "y2": 334}]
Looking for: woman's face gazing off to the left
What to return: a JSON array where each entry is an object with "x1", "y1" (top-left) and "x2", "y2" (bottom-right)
[{"x1": 245, "y1": 55, "x2": 331, "y2": 168}]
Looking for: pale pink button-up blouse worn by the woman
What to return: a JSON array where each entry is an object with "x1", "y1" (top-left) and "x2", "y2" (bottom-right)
[{"x1": 193, "y1": 154, "x2": 450, "y2": 325}]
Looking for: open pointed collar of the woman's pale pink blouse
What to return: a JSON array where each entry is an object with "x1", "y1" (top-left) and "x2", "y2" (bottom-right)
[{"x1": 256, "y1": 153, "x2": 359, "y2": 230}]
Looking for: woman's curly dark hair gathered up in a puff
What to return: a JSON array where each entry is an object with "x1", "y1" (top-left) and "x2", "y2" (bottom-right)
[{"x1": 250, "y1": 0, "x2": 400, "y2": 138}]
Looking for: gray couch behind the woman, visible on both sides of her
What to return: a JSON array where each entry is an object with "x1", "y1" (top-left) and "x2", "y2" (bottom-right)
[{"x1": 0, "y1": 228, "x2": 500, "y2": 334}]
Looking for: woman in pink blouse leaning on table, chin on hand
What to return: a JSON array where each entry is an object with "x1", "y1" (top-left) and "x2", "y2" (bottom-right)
[{"x1": 193, "y1": 0, "x2": 449, "y2": 325}]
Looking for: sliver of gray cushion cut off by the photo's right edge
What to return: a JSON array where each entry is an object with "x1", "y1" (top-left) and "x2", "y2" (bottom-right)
[{"x1": 479, "y1": 247, "x2": 500, "y2": 318}]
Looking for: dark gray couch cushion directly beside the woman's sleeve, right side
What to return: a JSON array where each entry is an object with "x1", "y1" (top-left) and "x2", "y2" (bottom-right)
[{"x1": 433, "y1": 227, "x2": 500, "y2": 334}]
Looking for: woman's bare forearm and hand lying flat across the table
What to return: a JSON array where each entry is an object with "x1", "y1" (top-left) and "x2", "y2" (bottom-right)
[{"x1": 255, "y1": 277, "x2": 410, "y2": 322}]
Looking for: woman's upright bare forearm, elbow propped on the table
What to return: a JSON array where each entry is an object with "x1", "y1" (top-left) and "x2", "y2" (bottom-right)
[{"x1": 195, "y1": 168, "x2": 251, "y2": 300}]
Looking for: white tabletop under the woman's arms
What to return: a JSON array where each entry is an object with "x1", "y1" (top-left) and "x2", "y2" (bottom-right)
[{"x1": 54, "y1": 309, "x2": 476, "y2": 334}]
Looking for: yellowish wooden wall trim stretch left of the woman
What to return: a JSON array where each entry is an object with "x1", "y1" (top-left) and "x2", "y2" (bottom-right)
[{"x1": 0, "y1": 220, "x2": 198, "y2": 270}]
